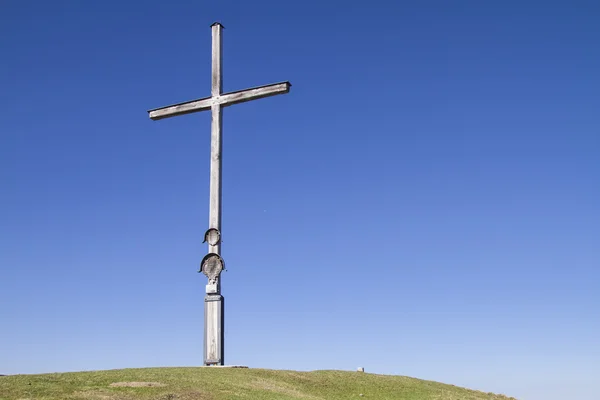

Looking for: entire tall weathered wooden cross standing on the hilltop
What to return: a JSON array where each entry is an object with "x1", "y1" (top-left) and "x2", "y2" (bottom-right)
[{"x1": 148, "y1": 22, "x2": 291, "y2": 365}]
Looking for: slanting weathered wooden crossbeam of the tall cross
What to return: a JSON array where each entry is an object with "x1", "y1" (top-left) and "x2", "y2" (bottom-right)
[{"x1": 148, "y1": 82, "x2": 292, "y2": 120}]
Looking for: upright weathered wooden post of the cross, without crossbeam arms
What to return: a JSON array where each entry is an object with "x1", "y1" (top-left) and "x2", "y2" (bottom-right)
[{"x1": 204, "y1": 22, "x2": 225, "y2": 365}]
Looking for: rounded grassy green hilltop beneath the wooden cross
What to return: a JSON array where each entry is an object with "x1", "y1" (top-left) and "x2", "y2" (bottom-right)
[{"x1": 0, "y1": 368, "x2": 512, "y2": 400}]
